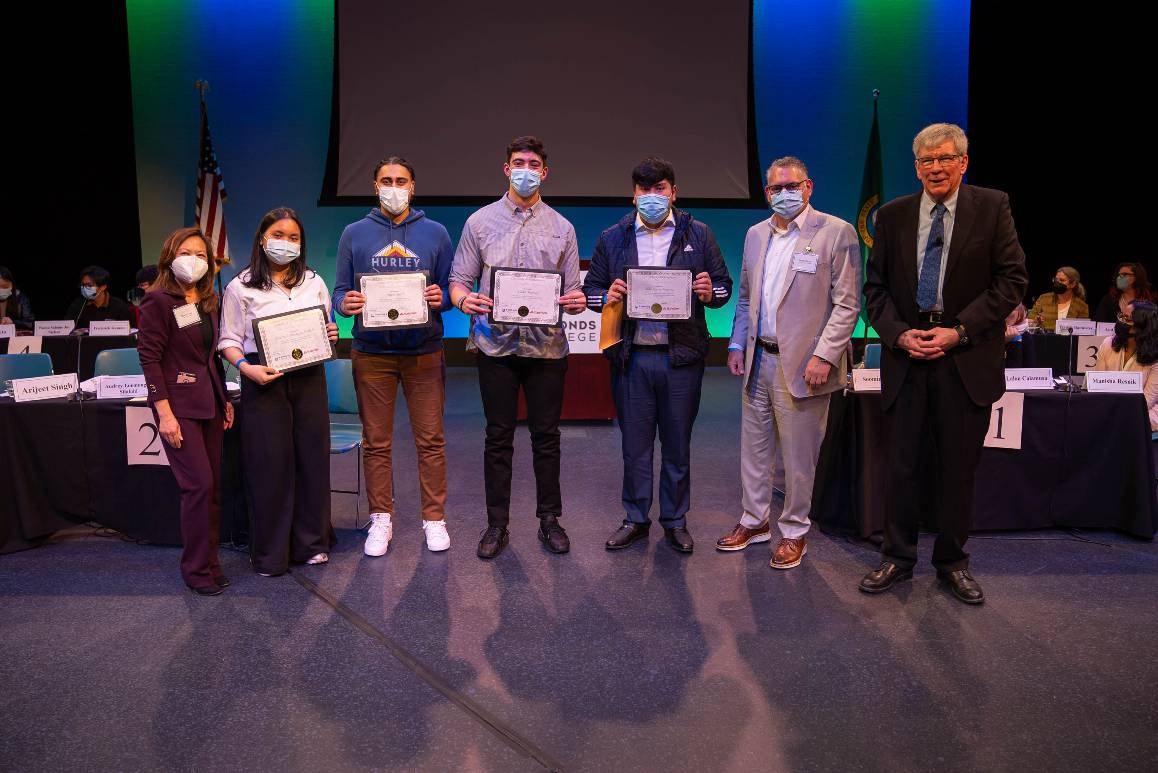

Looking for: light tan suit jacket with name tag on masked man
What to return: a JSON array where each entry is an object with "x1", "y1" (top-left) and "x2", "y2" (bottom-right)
[{"x1": 731, "y1": 208, "x2": 860, "y2": 398}]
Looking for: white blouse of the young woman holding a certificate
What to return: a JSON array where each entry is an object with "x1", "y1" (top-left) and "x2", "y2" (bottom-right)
[{"x1": 218, "y1": 268, "x2": 332, "y2": 354}]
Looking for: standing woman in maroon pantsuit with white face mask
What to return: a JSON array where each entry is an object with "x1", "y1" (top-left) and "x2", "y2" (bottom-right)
[{"x1": 137, "y1": 228, "x2": 233, "y2": 596}]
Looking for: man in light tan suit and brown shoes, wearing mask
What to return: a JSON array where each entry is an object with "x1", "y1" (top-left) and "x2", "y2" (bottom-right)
[{"x1": 716, "y1": 156, "x2": 860, "y2": 569}]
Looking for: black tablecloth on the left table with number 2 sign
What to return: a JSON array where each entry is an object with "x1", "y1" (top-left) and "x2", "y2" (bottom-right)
[{"x1": 0, "y1": 398, "x2": 248, "y2": 553}]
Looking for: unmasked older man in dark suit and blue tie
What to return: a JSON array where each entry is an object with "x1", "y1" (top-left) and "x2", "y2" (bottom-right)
[{"x1": 860, "y1": 124, "x2": 1028, "y2": 604}]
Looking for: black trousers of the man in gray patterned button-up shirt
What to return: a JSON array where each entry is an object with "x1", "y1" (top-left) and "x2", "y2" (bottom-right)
[{"x1": 478, "y1": 353, "x2": 567, "y2": 527}]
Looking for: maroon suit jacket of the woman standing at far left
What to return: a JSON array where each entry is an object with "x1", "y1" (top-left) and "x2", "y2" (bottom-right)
[{"x1": 137, "y1": 290, "x2": 226, "y2": 419}]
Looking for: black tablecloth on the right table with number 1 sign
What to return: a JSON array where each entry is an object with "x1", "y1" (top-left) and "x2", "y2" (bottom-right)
[{"x1": 812, "y1": 388, "x2": 1158, "y2": 539}]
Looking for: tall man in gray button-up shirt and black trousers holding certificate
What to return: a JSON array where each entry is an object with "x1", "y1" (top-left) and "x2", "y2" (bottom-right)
[{"x1": 450, "y1": 137, "x2": 586, "y2": 558}]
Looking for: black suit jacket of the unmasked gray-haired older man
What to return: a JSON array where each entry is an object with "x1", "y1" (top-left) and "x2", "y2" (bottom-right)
[{"x1": 865, "y1": 185, "x2": 1028, "y2": 408}]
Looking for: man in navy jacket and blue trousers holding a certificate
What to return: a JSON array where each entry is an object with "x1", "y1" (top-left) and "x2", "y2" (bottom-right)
[{"x1": 584, "y1": 157, "x2": 732, "y2": 553}]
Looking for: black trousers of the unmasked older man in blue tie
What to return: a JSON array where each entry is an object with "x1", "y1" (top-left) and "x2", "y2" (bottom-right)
[{"x1": 881, "y1": 356, "x2": 990, "y2": 572}]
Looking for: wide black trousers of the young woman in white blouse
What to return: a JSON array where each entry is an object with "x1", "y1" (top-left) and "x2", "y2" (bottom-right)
[{"x1": 239, "y1": 356, "x2": 334, "y2": 574}]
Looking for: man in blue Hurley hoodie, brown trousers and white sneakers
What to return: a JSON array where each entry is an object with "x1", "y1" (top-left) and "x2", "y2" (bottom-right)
[{"x1": 334, "y1": 156, "x2": 454, "y2": 555}]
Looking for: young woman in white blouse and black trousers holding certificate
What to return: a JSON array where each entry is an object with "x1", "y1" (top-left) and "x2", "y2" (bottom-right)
[{"x1": 218, "y1": 207, "x2": 338, "y2": 576}]
